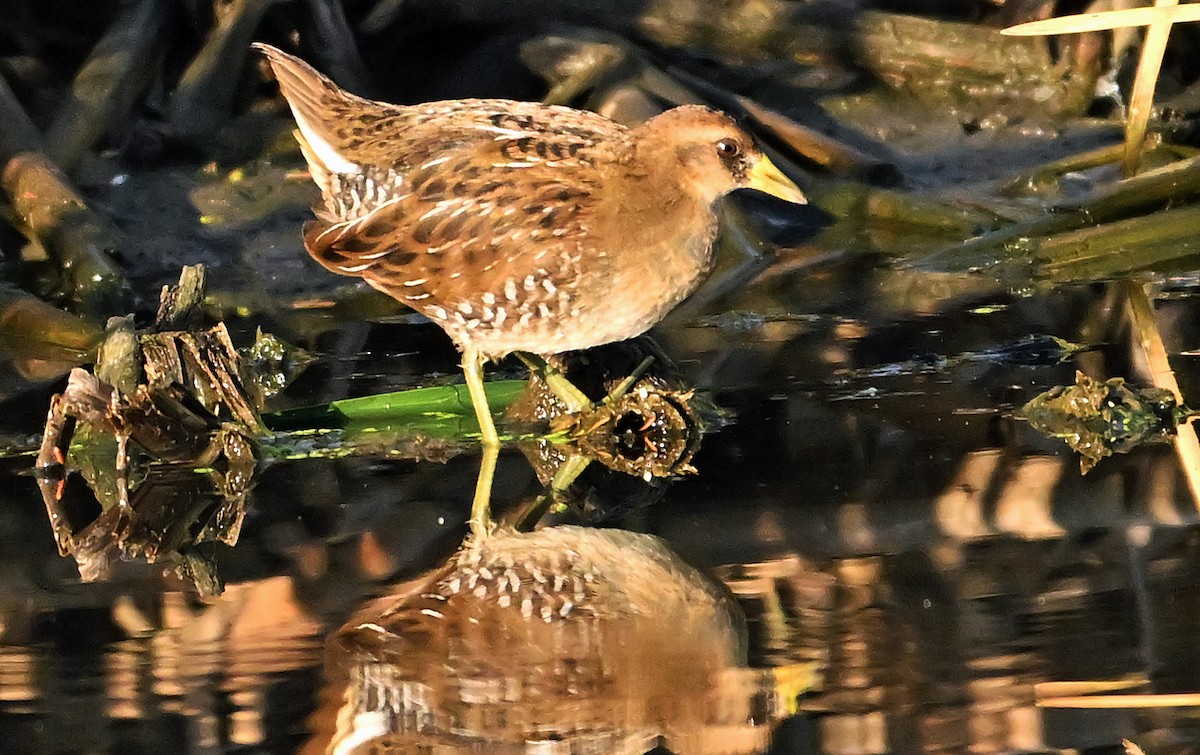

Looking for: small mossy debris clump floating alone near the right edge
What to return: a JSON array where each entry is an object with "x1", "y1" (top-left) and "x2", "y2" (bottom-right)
[{"x1": 1016, "y1": 372, "x2": 1193, "y2": 474}]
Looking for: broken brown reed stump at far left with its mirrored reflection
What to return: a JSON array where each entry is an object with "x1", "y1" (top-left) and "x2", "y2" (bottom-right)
[{"x1": 37, "y1": 268, "x2": 292, "y2": 593}]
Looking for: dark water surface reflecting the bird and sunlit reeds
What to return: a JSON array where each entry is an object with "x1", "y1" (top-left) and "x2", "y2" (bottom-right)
[{"x1": 0, "y1": 268, "x2": 1200, "y2": 755}]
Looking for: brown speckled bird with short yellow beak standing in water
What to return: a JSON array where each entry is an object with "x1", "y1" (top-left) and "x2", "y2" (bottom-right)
[{"x1": 254, "y1": 43, "x2": 806, "y2": 533}]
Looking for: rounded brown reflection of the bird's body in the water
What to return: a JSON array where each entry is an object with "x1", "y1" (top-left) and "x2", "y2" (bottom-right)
[{"x1": 330, "y1": 527, "x2": 779, "y2": 755}]
